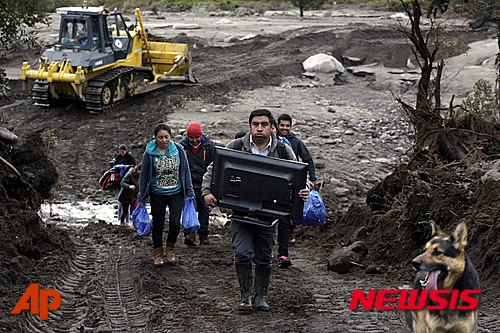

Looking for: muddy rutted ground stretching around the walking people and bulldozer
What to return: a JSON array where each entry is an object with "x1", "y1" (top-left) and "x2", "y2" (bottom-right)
[{"x1": 0, "y1": 5, "x2": 500, "y2": 332}]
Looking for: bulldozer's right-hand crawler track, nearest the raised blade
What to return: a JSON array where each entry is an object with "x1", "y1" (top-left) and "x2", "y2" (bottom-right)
[{"x1": 85, "y1": 67, "x2": 152, "y2": 114}]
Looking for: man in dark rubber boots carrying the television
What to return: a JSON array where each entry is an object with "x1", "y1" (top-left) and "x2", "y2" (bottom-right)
[{"x1": 202, "y1": 109, "x2": 309, "y2": 312}]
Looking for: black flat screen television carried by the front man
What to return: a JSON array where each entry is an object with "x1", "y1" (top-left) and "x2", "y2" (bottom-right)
[{"x1": 211, "y1": 147, "x2": 307, "y2": 225}]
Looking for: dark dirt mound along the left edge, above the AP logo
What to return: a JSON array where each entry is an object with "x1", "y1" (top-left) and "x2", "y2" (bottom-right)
[{"x1": 0, "y1": 133, "x2": 71, "y2": 329}]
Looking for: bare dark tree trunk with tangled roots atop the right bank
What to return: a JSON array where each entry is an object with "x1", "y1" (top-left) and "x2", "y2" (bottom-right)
[{"x1": 397, "y1": 0, "x2": 499, "y2": 164}]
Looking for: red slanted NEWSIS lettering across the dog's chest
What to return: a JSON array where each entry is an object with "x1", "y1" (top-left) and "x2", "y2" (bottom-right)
[{"x1": 349, "y1": 289, "x2": 481, "y2": 311}]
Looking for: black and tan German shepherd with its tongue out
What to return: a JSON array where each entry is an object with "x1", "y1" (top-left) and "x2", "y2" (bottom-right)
[{"x1": 406, "y1": 222, "x2": 479, "y2": 333}]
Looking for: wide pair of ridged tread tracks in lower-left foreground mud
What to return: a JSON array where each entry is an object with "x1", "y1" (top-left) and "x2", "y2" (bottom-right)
[{"x1": 21, "y1": 232, "x2": 150, "y2": 333}]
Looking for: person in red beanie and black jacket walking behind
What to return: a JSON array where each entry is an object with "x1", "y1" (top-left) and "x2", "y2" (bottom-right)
[{"x1": 179, "y1": 122, "x2": 215, "y2": 246}]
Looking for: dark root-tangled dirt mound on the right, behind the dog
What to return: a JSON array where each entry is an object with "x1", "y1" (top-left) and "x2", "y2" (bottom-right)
[{"x1": 310, "y1": 120, "x2": 500, "y2": 286}]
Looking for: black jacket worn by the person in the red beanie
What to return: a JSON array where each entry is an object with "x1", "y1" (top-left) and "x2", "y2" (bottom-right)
[{"x1": 179, "y1": 135, "x2": 215, "y2": 190}]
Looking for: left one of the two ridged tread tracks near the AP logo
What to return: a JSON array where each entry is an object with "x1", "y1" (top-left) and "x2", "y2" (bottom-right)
[{"x1": 22, "y1": 237, "x2": 96, "y2": 333}]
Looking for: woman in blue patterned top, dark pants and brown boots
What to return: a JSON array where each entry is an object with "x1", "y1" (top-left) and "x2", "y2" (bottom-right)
[{"x1": 138, "y1": 123, "x2": 194, "y2": 267}]
